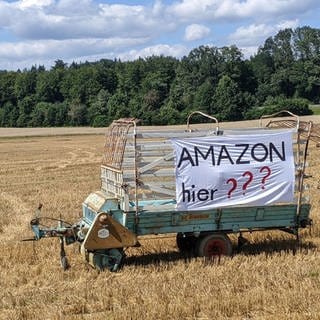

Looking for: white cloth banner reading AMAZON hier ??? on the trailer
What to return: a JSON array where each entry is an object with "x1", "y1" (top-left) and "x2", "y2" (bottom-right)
[{"x1": 171, "y1": 130, "x2": 295, "y2": 211}]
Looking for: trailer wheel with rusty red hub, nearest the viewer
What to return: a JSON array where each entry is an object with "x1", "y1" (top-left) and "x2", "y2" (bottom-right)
[{"x1": 197, "y1": 233, "x2": 232, "y2": 258}]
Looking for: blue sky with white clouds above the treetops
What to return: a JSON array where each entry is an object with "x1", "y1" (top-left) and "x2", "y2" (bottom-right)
[{"x1": 0, "y1": 0, "x2": 320, "y2": 70}]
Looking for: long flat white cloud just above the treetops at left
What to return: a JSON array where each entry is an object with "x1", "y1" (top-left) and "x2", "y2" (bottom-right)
[{"x1": 0, "y1": 38, "x2": 190, "y2": 70}]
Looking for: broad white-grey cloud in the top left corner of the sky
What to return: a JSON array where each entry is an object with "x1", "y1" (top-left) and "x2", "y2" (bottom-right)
[{"x1": 0, "y1": 0, "x2": 176, "y2": 40}]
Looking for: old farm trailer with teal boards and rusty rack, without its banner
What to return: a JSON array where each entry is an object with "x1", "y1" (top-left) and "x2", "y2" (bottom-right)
[{"x1": 29, "y1": 111, "x2": 313, "y2": 271}]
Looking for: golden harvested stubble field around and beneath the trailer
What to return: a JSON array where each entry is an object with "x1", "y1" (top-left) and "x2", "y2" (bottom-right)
[{"x1": 0, "y1": 119, "x2": 320, "y2": 320}]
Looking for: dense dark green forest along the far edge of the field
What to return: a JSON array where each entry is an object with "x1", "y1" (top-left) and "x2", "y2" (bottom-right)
[{"x1": 0, "y1": 26, "x2": 320, "y2": 127}]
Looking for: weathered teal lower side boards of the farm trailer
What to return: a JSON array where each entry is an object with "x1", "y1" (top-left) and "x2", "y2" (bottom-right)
[{"x1": 126, "y1": 204, "x2": 310, "y2": 236}]
